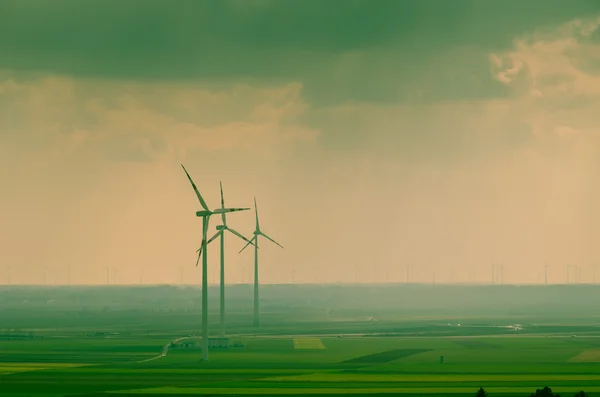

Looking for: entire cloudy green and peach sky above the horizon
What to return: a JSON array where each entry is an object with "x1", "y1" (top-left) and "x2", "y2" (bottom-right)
[{"x1": 0, "y1": 0, "x2": 600, "y2": 284}]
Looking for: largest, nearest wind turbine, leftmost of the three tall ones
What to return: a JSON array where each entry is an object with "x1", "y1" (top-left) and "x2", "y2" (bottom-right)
[{"x1": 181, "y1": 164, "x2": 250, "y2": 361}]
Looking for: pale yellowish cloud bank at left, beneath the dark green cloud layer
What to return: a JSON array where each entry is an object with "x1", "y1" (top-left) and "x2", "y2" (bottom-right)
[{"x1": 0, "y1": 76, "x2": 319, "y2": 161}]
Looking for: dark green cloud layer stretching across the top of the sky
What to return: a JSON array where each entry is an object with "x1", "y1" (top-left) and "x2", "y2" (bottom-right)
[{"x1": 0, "y1": 0, "x2": 600, "y2": 105}]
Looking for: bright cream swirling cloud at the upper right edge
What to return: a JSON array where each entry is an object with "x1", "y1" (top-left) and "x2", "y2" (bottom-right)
[{"x1": 490, "y1": 17, "x2": 600, "y2": 167}]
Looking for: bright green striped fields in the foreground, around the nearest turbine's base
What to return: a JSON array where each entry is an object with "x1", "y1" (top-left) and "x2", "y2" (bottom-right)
[{"x1": 0, "y1": 336, "x2": 600, "y2": 397}]
